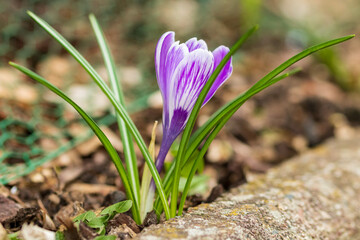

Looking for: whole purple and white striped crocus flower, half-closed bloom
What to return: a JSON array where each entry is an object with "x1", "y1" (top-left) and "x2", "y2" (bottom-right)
[{"x1": 155, "y1": 32, "x2": 232, "y2": 172}]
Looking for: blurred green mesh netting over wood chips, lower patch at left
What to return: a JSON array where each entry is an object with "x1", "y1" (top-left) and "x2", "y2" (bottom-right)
[{"x1": 0, "y1": 85, "x2": 150, "y2": 184}]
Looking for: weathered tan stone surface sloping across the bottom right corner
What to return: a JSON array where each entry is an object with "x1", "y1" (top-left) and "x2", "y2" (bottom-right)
[{"x1": 137, "y1": 135, "x2": 360, "y2": 240}]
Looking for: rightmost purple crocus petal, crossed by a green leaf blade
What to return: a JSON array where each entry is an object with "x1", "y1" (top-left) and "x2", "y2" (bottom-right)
[{"x1": 203, "y1": 46, "x2": 233, "y2": 106}]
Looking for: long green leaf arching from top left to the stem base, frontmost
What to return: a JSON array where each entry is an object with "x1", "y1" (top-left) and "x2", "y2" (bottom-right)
[{"x1": 27, "y1": 11, "x2": 170, "y2": 219}]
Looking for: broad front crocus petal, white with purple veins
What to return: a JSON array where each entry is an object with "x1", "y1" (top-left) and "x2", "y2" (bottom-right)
[{"x1": 168, "y1": 49, "x2": 214, "y2": 131}]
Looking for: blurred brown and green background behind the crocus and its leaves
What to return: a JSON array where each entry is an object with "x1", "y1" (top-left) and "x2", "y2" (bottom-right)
[{"x1": 0, "y1": 0, "x2": 360, "y2": 188}]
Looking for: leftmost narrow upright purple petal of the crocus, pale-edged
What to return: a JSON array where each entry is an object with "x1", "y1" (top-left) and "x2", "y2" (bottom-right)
[{"x1": 155, "y1": 32, "x2": 175, "y2": 96}]
